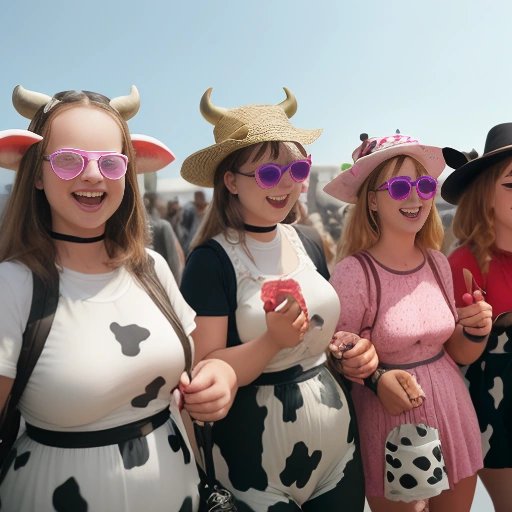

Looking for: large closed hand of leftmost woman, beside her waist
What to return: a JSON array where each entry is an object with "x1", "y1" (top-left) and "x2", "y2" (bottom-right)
[{"x1": 179, "y1": 359, "x2": 238, "y2": 421}]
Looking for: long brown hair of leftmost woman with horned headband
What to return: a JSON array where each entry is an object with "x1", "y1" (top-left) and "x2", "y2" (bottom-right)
[{"x1": 0, "y1": 91, "x2": 188, "y2": 352}]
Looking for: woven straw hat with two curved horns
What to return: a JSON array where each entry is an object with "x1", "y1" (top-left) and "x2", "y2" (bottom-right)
[{"x1": 181, "y1": 87, "x2": 322, "y2": 187}]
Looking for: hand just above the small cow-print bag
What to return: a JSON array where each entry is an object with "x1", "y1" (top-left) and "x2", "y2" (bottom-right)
[{"x1": 377, "y1": 370, "x2": 425, "y2": 416}]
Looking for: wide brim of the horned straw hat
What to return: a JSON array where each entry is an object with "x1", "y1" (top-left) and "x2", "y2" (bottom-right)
[{"x1": 181, "y1": 125, "x2": 322, "y2": 187}]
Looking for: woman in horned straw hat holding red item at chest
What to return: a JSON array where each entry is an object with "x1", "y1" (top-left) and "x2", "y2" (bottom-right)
[{"x1": 181, "y1": 89, "x2": 377, "y2": 512}]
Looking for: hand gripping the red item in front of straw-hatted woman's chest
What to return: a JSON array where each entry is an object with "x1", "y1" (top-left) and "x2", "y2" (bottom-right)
[{"x1": 266, "y1": 295, "x2": 309, "y2": 350}]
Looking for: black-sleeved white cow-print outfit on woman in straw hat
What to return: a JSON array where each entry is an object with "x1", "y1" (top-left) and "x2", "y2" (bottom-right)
[{"x1": 182, "y1": 224, "x2": 364, "y2": 512}]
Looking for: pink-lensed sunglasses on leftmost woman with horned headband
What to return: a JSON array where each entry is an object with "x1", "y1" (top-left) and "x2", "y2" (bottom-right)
[{"x1": 43, "y1": 148, "x2": 128, "y2": 180}]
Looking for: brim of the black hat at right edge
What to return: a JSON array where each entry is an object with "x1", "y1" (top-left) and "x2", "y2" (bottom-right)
[{"x1": 441, "y1": 145, "x2": 512, "y2": 204}]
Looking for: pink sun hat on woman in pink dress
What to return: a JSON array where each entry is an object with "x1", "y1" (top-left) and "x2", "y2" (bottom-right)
[{"x1": 324, "y1": 133, "x2": 446, "y2": 204}]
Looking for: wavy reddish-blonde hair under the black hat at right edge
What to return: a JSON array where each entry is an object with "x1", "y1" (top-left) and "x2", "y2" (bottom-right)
[{"x1": 453, "y1": 157, "x2": 512, "y2": 274}]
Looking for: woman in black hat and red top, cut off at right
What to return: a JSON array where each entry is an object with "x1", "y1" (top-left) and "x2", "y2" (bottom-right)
[{"x1": 441, "y1": 123, "x2": 512, "y2": 512}]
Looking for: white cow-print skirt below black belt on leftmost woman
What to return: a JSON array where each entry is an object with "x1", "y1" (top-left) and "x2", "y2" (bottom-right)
[{"x1": 0, "y1": 412, "x2": 199, "y2": 512}]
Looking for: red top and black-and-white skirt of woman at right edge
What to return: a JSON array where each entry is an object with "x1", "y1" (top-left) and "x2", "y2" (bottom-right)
[{"x1": 449, "y1": 246, "x2": 512, "y2": 469}]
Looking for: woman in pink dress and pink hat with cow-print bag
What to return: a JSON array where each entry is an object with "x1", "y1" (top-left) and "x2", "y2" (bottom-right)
[{"x1": 324, "y1": 133, "x2": 491, "y2": 512}]
